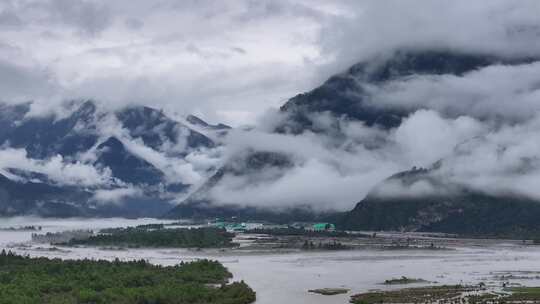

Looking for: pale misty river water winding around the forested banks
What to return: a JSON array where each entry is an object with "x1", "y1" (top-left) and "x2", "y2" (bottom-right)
[{"x1": 0, "y1": 217, "x2": 540, "y2": 304}]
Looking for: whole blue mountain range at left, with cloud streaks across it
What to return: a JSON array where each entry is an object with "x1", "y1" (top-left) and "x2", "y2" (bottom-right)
[{"x1": 0, "y1": 101, "x2": 224, "y2": 216}]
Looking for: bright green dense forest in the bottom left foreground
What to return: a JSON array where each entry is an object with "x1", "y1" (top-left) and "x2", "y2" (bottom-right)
[{"x1": 0, "y1": 251, "x2": 255, "y2": 304}]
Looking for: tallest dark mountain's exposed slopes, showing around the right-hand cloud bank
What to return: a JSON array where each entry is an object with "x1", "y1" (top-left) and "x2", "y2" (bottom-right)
[{"x1": 168, "y1": 50, "x2": 533, "y2": 221}]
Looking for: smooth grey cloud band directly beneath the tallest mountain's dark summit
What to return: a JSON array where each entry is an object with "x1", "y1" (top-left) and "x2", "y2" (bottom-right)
[{"x1": 364, "y1": 61, "x2": 540, "y2": 121}]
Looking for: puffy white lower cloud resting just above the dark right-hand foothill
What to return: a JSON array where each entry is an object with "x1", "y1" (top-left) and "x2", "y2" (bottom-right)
[{"x1": 211, "y1": 96, "x2": 540, "y2": 210}]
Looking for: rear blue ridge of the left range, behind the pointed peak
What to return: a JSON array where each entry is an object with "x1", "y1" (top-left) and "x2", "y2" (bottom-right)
[{"x1": 0, "y1": 101, "x2": 214, "y2": 158}]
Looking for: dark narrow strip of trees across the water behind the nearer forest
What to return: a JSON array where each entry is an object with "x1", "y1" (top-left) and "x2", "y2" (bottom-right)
[{"x1": 67, "y1": 226, "x2": 235, "y2": 248}]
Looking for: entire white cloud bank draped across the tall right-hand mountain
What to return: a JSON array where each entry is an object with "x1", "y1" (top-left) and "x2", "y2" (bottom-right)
[{"x1": 202, "y1": 54, "x2": 540, "y2": 210}]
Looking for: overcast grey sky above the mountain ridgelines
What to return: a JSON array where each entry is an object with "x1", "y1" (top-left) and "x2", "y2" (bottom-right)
[{"x1": 4, "y1": 0, "x2": 540, "y2": 125}]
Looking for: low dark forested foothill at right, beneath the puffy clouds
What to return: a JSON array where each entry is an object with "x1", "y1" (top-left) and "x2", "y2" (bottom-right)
[{"x1": 339, "y1": 166, "x2": 540, "y2": 238}]
